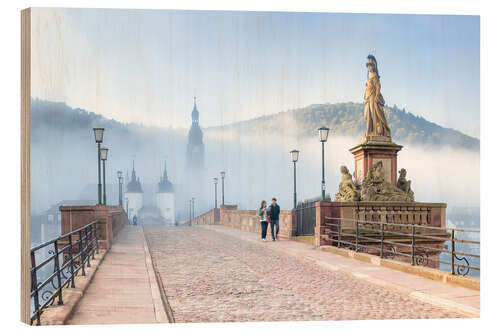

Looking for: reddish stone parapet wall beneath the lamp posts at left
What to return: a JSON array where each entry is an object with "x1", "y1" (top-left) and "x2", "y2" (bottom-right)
[{"x1": 59, "y1": 205, "x2": 128, "y2": 249}]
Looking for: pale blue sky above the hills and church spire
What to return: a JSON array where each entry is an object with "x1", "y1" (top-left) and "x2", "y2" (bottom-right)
[{"x1": 32, "y1": 8, "x2": 479, "y2": 137}]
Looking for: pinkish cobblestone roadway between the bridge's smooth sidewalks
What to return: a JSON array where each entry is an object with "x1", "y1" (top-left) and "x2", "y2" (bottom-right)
[{"x1": 145, "y1": 227, "x2": 463, "y2": 322}]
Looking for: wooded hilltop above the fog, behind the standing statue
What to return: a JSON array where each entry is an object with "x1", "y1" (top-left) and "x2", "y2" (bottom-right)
[{"x1": 210, "y1": 102, "x2": 480, "y2": 150}]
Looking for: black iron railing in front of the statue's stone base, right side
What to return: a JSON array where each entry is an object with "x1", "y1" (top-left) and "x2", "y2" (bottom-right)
[{"x1": 325, "y1": 217, "x2": 480, "y2": 275}]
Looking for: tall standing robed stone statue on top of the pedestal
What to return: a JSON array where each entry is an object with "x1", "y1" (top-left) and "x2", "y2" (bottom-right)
[{"x1": 364, "y1": 54, "x2": 391, "y2": 141}]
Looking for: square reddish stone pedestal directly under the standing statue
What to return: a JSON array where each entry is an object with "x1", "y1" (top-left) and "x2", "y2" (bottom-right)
[{"x1": 349, "y1": 140, "x2": 403, "y2": 185}]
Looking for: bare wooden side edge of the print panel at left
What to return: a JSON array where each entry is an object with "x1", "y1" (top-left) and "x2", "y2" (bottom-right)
[{"x1": 21, "y1": 8, "x2": 31, "y2": 324}]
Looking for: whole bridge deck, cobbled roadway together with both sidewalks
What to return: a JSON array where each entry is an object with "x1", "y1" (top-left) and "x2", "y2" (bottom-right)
[{"x1": 37, "y1": 204, "x2": 479, "y2": 324}]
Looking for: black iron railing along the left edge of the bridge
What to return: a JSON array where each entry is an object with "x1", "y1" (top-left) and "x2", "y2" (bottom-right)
[{"x1": 30, "y1": 221, "x2": 99, "y2": 325}]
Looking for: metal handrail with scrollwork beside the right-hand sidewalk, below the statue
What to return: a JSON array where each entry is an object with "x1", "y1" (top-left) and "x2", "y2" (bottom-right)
[{"x1": 324, "y1": 216, "x2": 480, "y2": 275}]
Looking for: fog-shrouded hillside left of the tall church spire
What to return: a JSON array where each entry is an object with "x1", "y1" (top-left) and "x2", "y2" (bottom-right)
[{"x1": 31, "y1": 99, "x2": 186, "y2": 213}]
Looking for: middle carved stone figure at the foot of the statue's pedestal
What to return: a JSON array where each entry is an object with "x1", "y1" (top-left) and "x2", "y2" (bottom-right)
[{"x1": 361, "y1": 161, "x2": 415, "y2": 202}]
